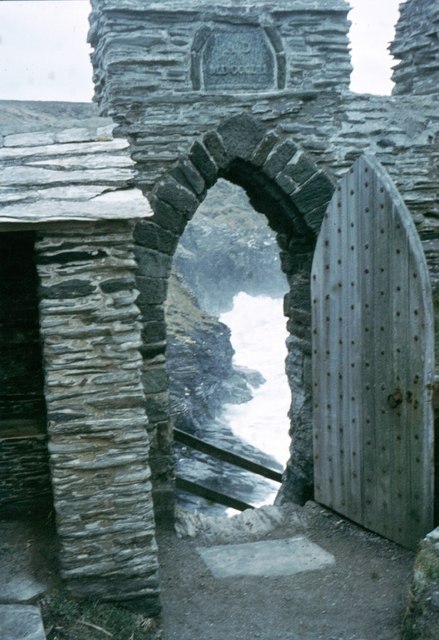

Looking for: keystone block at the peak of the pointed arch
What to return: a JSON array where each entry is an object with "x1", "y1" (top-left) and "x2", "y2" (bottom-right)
[{"x1": 218, "y1": 113, "x2": 266, "y2": 160}]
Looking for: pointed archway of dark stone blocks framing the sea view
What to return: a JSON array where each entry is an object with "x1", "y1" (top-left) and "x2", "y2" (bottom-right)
[{"x1": 135, "y1": 114, "x2": 334, "y2": 521}]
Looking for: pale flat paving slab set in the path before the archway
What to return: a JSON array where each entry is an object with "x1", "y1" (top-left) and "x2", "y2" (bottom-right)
[{"x1": 197, "y1": 536, "x2": 335, "y2": 578}]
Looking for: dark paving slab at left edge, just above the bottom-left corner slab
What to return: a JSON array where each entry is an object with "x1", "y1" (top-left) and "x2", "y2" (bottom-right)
[{"x1": 0, "y1": 522, "x2": 45, "y2": 604}]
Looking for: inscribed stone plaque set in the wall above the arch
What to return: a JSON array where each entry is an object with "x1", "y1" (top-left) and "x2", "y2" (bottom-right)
[{"x1": 201, "y1": 25, "x2": 276, "y2": 91}]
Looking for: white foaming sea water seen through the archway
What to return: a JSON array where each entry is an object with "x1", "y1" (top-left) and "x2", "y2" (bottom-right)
[{"x1": 176, "y1": 292, "x2": 291, "y2": 515}]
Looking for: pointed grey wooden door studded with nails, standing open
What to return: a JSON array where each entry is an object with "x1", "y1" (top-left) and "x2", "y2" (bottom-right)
[{"x1": 312, "y1": 156, "x2": 434, "y2": 548}]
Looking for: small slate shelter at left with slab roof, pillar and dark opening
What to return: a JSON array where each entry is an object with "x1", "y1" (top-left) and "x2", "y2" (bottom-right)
[{"x1": 0, "y1": 120, "x2": 159, "y2": 614}]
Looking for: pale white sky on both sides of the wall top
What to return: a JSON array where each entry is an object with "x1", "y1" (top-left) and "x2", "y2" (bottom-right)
[{"x1": 0, "y1": 0, "x2": 401, "y2": 102}]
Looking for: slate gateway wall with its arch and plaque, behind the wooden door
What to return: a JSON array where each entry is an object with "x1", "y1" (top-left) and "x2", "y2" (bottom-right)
[{"x1": 90, "y1": 0, "x2": 439, "y2": 520}]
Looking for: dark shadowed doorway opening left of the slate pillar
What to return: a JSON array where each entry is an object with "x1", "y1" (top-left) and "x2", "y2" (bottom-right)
[{"x1": 0, "y1": 231, "x2": 51, "y2": 508}]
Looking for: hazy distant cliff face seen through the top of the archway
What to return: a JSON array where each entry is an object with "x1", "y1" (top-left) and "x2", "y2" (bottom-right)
[{"x1": 175, "y1": 180, "x2": 287, "y2": 314}]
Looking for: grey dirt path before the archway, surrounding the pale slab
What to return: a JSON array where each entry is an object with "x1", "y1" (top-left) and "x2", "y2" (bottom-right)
[{"x1": 159, "y1": 503, "x2": 414, "y2": 640}]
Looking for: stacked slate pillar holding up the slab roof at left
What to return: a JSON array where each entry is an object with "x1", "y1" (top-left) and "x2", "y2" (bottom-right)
[{"x1": 36, "y1": 221, "x2": 159, "y2": 614}]
